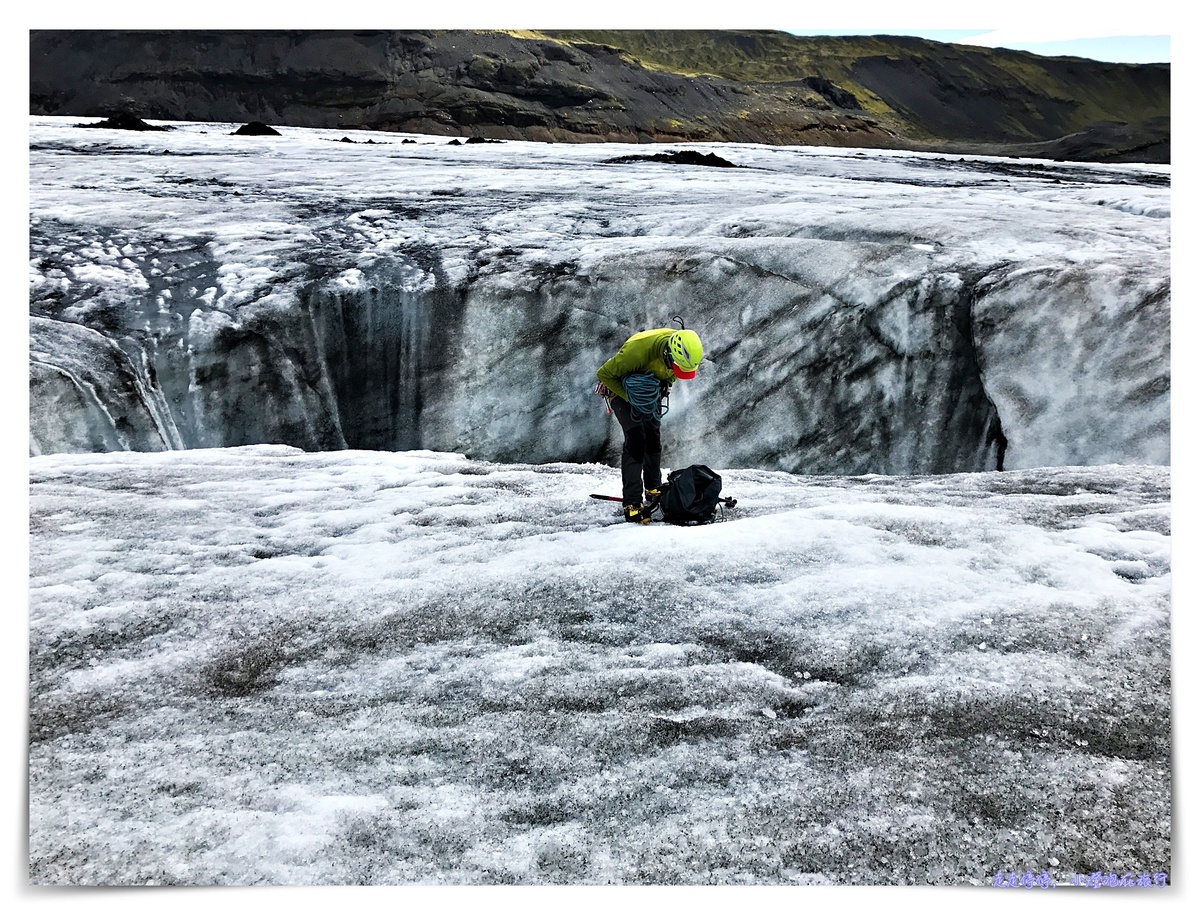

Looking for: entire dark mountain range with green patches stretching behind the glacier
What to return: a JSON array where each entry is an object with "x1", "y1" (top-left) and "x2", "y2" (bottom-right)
[{"x1": 30, "y1": 30, "x2": 1170, "y2": 162}]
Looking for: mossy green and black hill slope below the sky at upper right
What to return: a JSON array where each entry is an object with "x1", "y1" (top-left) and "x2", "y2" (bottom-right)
[{"x1": 547, "y1": 30, "x2": 1170, "y2": 150}]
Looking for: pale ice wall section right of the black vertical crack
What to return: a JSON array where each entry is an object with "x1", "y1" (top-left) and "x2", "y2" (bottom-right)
[{"x1": 973, "y1": 264, "x2": 1171, "y2": 467}]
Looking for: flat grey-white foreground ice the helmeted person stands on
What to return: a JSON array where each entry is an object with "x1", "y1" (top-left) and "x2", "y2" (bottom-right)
[{"x1": 29, "y1": 445, "x2": 1171, "y2": 885}]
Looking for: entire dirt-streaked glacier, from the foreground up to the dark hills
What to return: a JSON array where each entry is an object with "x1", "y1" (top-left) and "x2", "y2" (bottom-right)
[{"x1": 29, "y1": 112, "x2": 1187, "y2": 885}]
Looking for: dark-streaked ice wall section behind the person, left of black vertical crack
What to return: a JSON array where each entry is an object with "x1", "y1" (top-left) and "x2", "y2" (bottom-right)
[{"x1": 431, "y1": 239, "x2": 1002, "y2": 473}]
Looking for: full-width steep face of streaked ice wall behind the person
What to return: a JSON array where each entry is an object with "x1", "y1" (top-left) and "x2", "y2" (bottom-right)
[{"x1": 30, "y1": 241, "x2": 1169, "y2": 473}]
